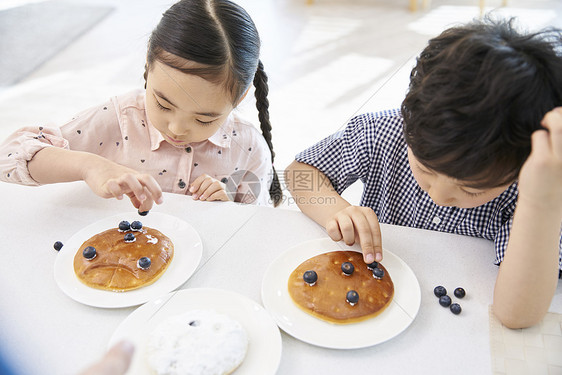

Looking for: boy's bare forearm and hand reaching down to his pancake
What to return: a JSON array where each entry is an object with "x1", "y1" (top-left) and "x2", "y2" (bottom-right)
[{"x1": 285, "y1": 161, "x2": 382, "y2": 263}]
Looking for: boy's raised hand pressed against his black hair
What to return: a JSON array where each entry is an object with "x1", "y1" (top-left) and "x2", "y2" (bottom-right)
[{"x1": 519, "y1": 107, "x2": 562, "y2": 214}]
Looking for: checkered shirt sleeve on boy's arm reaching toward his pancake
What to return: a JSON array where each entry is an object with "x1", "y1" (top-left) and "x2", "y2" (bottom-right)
[{"x1": 292, "y1": 115, "x2": 371, "y2": 194}]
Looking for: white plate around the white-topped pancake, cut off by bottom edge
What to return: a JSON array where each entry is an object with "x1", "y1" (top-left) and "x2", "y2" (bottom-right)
[{"x1": 108, "y1": 288, "x2": 282, "y2": 375}]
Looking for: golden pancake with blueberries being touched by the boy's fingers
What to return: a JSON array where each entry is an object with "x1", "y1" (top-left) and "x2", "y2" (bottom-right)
[{"x1": 288, "y1": 251, "x2": 394, "y2": 324}]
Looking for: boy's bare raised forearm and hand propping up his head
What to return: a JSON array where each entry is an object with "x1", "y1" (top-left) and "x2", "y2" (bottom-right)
[{"x1": 493, "y1": 108, "x2": 562, "y2": 328}]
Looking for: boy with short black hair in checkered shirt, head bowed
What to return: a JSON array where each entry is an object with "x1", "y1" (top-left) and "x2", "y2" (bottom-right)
[{"x1": 285, "y1": 19, "x2": 562, "y2": 328}]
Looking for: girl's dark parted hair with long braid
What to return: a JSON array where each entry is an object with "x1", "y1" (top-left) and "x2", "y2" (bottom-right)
[{"x1": 140, "y1": 0, "x2": 283, "y2": 206}]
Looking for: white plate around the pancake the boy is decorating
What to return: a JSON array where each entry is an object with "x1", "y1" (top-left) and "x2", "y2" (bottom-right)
[{"x1": 261, "y1": 238, "x2": 421, "y2": 349}]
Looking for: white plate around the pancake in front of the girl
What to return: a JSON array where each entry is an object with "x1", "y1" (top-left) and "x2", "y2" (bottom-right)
[{"x1": 55, "y1": 212, "x2": 203, "y2": 308}]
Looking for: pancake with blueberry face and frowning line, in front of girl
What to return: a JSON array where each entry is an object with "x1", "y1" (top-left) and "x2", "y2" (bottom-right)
[{"x1": 74, "y1": 221, "x2": 174, "y2": 292}]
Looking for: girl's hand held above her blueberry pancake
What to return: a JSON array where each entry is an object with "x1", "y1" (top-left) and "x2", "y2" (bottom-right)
[{"x1": 84, "y1": 158, "x2": 163, "y2": 211}]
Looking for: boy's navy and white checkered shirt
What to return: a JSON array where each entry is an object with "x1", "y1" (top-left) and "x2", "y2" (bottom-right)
[{"x1": 296, "y1": 110, "x2": 562, "y2": 275}]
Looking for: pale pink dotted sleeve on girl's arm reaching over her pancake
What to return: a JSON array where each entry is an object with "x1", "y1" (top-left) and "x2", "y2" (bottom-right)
[{"x1": 0, "y1": 97, "x2": 119, "y2": 186}]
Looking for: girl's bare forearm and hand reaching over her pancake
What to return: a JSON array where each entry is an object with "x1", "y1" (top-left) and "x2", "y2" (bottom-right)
[{"x1": 27, "y1": 147, "x2": 162, "y2": 211}]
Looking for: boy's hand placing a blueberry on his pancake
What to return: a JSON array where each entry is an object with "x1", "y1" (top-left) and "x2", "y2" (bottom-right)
[{"x1": 326, "y1": 206, "x2": 382, "y2": 263}]
